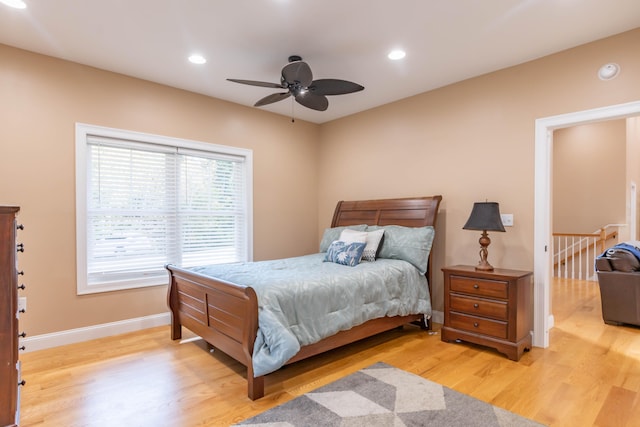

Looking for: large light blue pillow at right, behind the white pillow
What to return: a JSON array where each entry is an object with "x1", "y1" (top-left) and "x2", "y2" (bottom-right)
[{"x1": 368, "y1": 225, "x2": 435, "y2": 274}]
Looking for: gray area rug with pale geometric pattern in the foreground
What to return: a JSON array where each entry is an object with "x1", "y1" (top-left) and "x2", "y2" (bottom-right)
[{"x1": 236, "y1": 363, "x2": 542, "y2": 427}]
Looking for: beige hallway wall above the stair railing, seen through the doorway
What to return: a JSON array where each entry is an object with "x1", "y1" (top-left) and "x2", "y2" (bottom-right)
[{"x1": 552, "y1": 119, "x2": 628, "y2": 234}]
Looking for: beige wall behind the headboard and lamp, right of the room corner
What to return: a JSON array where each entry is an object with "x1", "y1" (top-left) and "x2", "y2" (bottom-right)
[{"x1": 319, "y1": 30, "x2": 640, "y2": 310}]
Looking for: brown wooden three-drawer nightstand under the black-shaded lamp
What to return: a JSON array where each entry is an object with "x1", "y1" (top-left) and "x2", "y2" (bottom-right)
[{"x1": 441, "y1": 265, "x2": 533, "y2": 361}]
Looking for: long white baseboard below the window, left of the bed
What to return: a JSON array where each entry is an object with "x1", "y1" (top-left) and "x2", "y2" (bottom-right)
[{"x1": 20, "y1": 312, "x2": 171, "y2": 353}]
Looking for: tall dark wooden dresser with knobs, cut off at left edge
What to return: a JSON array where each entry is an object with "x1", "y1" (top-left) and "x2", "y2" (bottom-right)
[{"x1": 0, "y1": 206, "x2": 24, "y2": 426}]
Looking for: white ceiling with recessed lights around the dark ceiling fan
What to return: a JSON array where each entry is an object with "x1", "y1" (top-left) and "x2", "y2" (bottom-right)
[{"x1": 0, "y1": 0, "x2": 640, "y2": 123}]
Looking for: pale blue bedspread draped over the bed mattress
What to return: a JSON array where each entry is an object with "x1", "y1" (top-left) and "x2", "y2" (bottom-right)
[{"x1": 191, "y1": 253, "x2": 431, "y2": 377}]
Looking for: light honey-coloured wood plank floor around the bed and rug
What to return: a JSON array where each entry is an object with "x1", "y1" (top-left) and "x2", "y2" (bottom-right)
[{"x1": 21, "y1": 281, "x2": 640, "y2": 427}]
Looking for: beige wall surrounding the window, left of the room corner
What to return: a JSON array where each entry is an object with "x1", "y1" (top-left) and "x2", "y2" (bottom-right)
[{"x1": 0, "y1": 45, "x2": 319, "y2": 336}]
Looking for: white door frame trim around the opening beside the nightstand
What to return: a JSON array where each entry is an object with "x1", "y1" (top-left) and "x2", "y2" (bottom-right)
[{"x1": 533, "y1": 101, "x2": 640, "y2": 348}]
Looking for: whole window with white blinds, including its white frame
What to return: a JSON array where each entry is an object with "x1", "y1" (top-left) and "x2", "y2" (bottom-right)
[{"x1": 76, "y1": 124, "x2": 252, "y2": 294}]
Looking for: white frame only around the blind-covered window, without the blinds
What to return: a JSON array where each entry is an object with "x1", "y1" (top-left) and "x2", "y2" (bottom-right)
[{"x1": 75, "y1": 123, "x2": 253, "y2": 295}]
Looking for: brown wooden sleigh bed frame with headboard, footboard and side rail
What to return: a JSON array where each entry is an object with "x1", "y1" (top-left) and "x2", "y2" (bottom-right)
[{"x1": 166, "y1": 196, "x2": 442, "y2": 400}]
